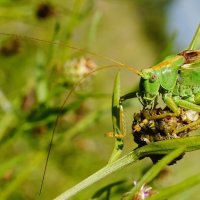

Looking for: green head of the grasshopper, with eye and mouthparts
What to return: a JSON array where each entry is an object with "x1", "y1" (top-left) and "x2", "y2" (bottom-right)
[{"x1": 138, "y1": 68, "x2": 160, "y2": 107}]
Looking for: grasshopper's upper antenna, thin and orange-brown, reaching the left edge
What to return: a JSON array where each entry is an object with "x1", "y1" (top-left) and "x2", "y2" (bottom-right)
[{"x1": 0, "y1": 32, "x2": 140, "y2": 75}]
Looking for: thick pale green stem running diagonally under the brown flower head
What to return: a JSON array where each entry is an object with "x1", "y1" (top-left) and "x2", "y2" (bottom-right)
[{"x1": 55, "y1": 136, "x2": 200, "y2": 200}]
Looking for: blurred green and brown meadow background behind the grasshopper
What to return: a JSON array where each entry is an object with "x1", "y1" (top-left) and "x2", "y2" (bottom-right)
[{"x1": 0, "y1": 0, "x2": 200, "y2": 200}]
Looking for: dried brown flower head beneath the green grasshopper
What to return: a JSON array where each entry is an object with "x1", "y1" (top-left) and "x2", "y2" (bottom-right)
[{"x1": 132, "y1": 107, "x2": 200, "y2": 162}]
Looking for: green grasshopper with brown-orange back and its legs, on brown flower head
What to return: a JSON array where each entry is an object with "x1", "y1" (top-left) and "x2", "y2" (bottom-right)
[{"x1": 110, "y1": 26, "x2": 200, "y2": 167}]
